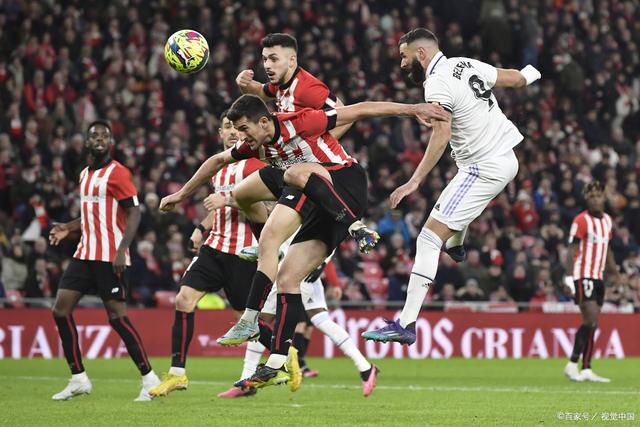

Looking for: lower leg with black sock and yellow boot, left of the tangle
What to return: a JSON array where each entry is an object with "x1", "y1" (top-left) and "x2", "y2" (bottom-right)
[{"x1": 149, "y1": 285, "x2": 205, "y2": 397}]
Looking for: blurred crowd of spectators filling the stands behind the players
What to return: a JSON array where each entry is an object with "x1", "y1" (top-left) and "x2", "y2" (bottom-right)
[{"x1": 0, "y1": 0, "x2": 640, "y2": 310}]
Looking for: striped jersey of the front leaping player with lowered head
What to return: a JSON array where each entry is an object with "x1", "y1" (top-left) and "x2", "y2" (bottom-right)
[{"x1": 231, "y1": 108, "x2": 355, "y2": 169}]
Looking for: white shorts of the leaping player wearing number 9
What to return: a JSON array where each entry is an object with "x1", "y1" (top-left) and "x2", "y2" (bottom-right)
[{"x1": 430, "y1": 150, "x2": 518, "y2": 231}]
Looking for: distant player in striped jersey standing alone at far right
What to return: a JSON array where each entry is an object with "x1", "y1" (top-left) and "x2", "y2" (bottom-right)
[{"x1": 564, "y1": 181, "x2": 618, "y2": 382}]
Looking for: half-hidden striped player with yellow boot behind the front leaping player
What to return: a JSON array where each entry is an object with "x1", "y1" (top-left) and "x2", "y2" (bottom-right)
[{"x1": 150, "y1": 111, "x2": 271, "y2": 396}]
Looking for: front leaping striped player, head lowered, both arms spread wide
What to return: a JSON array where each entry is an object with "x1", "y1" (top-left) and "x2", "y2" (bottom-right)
[{"x1": 160, "y1": 95, "x2": 445, "y2": 391}]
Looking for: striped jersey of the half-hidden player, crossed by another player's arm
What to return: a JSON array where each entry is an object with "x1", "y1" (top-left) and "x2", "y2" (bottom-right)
[{"x1": 205, "y1": 159, "x2": 265, "y2": 255}]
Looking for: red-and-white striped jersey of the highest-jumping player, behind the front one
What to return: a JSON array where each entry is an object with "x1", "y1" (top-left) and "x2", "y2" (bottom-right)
[{"x1": 262, "y1": 67, "x2": 336, "y2": 113}]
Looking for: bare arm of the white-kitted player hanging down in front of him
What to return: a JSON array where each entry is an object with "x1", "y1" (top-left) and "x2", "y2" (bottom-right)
[{"x1": 389, "y1": 113, "x2": 451, "y2": 208}]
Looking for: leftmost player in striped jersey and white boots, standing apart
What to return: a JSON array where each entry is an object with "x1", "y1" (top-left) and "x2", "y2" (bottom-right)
[{"x1": 49, "y1": 120, "x2": 160, "y2": 401}]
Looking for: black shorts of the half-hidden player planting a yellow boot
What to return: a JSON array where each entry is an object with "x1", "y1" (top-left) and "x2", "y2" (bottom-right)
[{"x1": 180, "y1": 246, "x2": 257, "y2": 310}]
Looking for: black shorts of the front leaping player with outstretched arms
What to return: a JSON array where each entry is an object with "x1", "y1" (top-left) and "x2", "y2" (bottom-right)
[{"x1": 292, "y1": 163, "x2": 367, "y2": 255}]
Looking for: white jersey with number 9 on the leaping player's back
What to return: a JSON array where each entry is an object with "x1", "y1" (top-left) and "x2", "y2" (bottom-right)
[{"x1": 424, "y1": 52, "x2": 524, "y2": 165}]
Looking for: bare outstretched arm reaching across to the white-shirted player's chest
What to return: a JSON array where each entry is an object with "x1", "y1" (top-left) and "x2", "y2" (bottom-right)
[{"x1": 336, "y1": 101, "x2": 449, "y2": 127}]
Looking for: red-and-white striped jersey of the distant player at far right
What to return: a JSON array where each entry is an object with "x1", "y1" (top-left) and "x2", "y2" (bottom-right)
[{"x1": 569, "y1": 211, "x2": 613, "y2": 280}]
